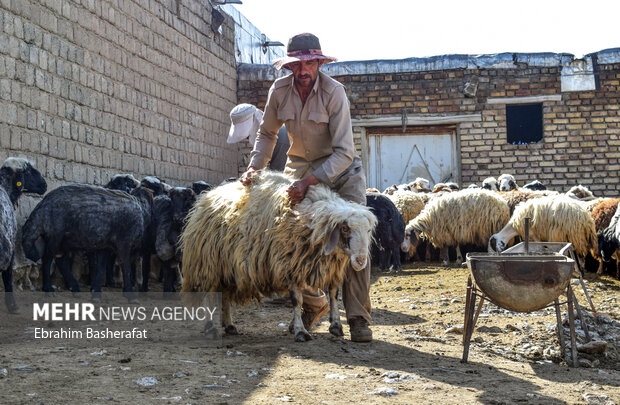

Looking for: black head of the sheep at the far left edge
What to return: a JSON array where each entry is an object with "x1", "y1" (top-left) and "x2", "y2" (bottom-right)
[{"x1": 0, "y1": 158, "x2": 47, "y2": 207}]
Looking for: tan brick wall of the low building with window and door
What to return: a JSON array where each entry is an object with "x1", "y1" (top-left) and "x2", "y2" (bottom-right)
[{"x1": 238, "y1": 55, "x2": 620, "y2": 196}]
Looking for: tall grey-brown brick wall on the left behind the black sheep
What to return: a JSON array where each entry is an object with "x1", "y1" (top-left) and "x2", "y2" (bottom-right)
[{"x1": 0, "y1": 0, "x2": 239, "y2": 188}]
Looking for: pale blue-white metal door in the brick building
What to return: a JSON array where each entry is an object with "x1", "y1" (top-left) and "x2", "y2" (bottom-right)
[{"x1": 366, "y1": 126, "x2": 461, "y2": 191}]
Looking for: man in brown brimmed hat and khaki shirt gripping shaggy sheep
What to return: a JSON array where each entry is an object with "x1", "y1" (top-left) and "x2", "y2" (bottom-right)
[{"x1": 241, "y1": 33, "x2": 372, "y2": 342}]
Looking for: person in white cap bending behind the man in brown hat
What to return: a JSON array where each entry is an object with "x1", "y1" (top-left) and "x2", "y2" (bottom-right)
[{"x1": 226, "y1": 104, "x2": 291, "y2": 172}]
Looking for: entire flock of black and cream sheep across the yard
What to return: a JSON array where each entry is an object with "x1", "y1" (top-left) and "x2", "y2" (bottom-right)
[{"x1": 0, "y1": 158, "x2": 620, "y2": 341}]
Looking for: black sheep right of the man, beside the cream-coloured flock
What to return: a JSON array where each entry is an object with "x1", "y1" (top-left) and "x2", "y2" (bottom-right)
[{"x1": 366, "y1": 193, "x2": 405, "y2": 270}]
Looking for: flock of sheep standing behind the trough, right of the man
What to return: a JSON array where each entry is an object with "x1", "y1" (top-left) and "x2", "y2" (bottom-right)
[{"x1": 367, "y1": 174, "x2": 620, "y2": 277}]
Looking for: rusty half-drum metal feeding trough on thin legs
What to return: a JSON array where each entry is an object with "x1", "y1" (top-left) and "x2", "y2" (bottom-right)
[{"x1": 462, "y1": 219, "x2": 594, "y2": 366}]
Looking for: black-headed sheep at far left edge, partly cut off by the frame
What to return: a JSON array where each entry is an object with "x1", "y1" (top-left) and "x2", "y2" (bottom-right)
[{"x1": 0, "y1": 157, "x2": 47, "y2": 313}]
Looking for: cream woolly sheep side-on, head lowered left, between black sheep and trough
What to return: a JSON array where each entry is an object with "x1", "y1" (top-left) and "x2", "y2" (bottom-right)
[{"x1": 401, "y1": 189, "x2": 510, "y2": 265}]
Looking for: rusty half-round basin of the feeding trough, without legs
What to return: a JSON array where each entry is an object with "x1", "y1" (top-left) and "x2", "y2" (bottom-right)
[{"x1": 467, "y1": 251, "x2": 575, "y2": 312}]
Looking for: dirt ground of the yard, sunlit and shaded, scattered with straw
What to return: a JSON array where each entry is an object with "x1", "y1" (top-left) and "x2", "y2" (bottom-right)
[{"x1": 0, "y1": 263, "x2": 620, "y2": 404}]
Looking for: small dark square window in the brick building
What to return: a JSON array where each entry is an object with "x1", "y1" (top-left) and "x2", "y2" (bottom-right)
[{"x1": 506, "y1": 103, "x2": 542, "y2": 145}]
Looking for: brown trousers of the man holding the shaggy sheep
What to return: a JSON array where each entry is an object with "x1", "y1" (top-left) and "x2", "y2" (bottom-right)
[{"x1": 302, "y1": 158, "x2": 372, "y2": 324}]
